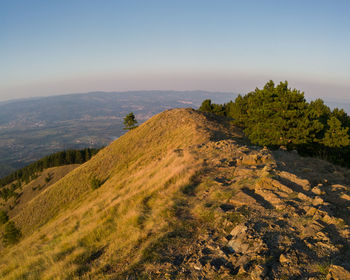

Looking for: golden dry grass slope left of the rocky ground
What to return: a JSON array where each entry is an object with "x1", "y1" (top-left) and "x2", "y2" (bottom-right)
[{"x1": 0, "y1": 109, "x2": 241, "y2": 279}]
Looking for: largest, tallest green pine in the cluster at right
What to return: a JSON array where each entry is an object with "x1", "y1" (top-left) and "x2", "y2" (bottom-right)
[{"x1": 240, "y1": 81, "x2": 322, "y2": 147}]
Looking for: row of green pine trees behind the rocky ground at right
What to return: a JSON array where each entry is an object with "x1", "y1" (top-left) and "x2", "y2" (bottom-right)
[{"x1": 199, "y1": 81, "x2": 350, "y2": 167}]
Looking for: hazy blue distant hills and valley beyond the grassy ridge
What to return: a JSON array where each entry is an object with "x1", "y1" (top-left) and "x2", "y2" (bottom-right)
[{"x1": 0, "y1": 91, "x2": 236, "y2": 178}]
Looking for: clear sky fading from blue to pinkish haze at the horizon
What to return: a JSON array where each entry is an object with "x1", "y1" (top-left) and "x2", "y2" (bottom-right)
[{"x1": 0, "y1": 0, "x2": 350, "y2": 100}]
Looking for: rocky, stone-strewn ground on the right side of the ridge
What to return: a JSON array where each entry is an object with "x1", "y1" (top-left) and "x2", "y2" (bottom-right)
[{"x1": 130, "y1": 140, "x2": 350, "y2": 280}]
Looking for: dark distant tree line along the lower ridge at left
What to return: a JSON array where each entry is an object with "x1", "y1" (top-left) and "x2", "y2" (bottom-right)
[{"x1": 0, "y1": 148, "x2": 99, "y2": 196}]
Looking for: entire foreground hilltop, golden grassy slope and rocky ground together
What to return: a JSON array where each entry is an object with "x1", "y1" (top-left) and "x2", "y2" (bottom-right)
[{"x1": 0, "y1": 109, "x2": 350, "y2": 279}]
